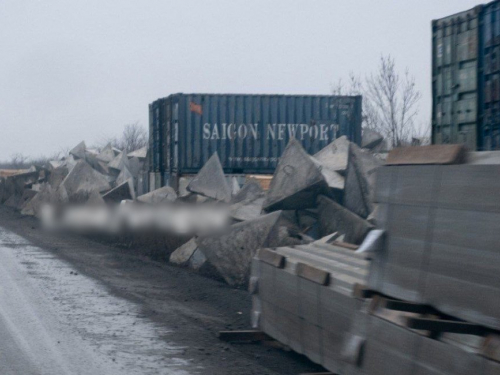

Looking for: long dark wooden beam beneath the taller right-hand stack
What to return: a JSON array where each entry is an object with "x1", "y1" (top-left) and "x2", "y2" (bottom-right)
[{"x1": 406, "y1": 317, "x2": 487, "y2": 336}]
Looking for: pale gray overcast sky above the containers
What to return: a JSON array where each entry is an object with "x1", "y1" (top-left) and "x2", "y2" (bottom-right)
[{"x1": 0, "y1": 0, "x2": 478, "y2": 160}]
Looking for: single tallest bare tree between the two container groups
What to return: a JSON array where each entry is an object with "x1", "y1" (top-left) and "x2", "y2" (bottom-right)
[{"x1": 365, "y1": 56, "x2": 422, "y2": 147}]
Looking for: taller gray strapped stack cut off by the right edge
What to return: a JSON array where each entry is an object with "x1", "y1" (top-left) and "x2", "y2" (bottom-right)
[{"x1": 369, "y1": 165, "x2": 500, "y2": 329}]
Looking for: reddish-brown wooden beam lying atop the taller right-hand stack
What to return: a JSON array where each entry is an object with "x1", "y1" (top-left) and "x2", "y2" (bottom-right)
[{"x1": 386, "y1": 145, "x2": 467, "y2": 165}]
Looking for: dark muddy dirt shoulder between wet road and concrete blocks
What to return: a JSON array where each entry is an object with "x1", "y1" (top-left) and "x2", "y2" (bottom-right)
[{"x1": 0, "y1": 206, "x2": 324, "y2": 375}]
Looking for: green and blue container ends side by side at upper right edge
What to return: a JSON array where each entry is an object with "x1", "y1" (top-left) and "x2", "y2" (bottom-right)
[{"x1": 432, "y1": 0, "x2": 500, "y2": 150}]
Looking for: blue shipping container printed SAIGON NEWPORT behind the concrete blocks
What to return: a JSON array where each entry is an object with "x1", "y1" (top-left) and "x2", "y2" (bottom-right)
[{"x1": 149, "y1": 94, "x2": 362, "y2": 187}]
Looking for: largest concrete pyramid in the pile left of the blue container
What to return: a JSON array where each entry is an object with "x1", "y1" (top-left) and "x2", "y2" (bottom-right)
[{"x1": 61, "y1": 160, "x2": 111, "y2": 200}]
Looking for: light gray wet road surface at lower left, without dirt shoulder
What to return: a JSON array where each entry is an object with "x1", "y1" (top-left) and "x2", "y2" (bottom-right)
[{"x1": 0, "y1": 227, "x2": 191, "y2": 375}]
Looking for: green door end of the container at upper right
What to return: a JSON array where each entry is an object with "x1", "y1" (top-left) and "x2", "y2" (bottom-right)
[{"x1": 432, "y1": 7, "x2": 482, "y2": 150}]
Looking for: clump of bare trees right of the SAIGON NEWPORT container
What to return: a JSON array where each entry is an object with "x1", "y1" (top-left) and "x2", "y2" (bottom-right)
[{"x1": 332, "y1": 56, "x2": 421, "y2": 147}]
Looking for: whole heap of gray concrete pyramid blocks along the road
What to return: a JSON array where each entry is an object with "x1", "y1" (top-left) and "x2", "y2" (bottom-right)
[{"x1": 2, "y1": 137, "x2": 386, "y2": 286}]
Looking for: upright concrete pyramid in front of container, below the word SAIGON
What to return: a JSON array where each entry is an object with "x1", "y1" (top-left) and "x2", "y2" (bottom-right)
[{"x1": 187, "y1": 153, "x2": 231, "y2": 202}]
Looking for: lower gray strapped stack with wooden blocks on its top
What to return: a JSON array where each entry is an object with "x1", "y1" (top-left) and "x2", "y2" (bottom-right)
[{"x1": 250, "y1": 241, "x2": 368, "y2": 373}]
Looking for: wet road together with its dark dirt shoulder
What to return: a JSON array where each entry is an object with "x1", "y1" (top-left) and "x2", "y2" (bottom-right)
[{"x1": 0, "y1": 205, "x2": 322, "y2": 375}]
